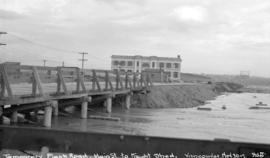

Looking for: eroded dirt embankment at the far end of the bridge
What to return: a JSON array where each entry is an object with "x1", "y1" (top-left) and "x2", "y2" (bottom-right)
[{"x1": 132, "y1": 83, "x2": 244, "y2": 108}]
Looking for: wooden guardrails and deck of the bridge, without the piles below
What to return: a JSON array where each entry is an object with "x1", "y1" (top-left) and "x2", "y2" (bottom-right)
[{"x1": 0, "y1": 64, "x2": 152, "y2": 105}]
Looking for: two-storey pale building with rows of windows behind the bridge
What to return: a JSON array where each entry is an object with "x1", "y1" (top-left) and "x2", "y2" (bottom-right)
[{"x1": 111, "y1": 55, "x2": 182, "y2": 80}]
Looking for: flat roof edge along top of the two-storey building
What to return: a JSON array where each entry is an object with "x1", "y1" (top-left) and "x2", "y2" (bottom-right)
[{"x1": 111, "y1": 55, "x2": 182, "y2": 61}]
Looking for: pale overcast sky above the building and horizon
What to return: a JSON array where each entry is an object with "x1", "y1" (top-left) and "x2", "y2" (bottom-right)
[{"x1": 0, "y1": 0, "x2": 270, "y2": 77}]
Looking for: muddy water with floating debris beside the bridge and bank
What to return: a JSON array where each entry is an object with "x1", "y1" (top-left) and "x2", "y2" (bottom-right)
[{"x1": 53, "y1": 93, "x2": 270, "y2": 144}]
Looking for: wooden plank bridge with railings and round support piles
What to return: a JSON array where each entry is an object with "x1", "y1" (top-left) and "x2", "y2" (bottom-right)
[{"x1": 0, "y1": 63, "x2": 152, "y2": 127}]
